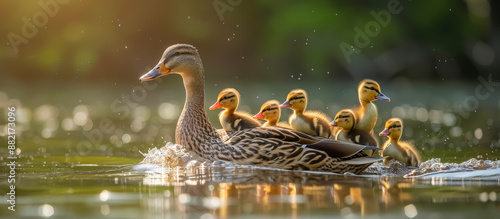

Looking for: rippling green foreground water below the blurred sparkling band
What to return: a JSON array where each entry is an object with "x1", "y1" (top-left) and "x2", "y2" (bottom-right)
[{"x1": 0, "y1": 156, "x2": 500, "y2": 218}]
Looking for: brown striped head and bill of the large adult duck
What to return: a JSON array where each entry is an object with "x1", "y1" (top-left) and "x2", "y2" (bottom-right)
[{"x1": 139, "y1": 44, "x2": 203, "y2": 82}]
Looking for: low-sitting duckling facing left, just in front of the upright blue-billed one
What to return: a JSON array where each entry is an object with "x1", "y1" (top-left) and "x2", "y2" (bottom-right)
[{"x1": 330, "y1": 109, "x2": 377, "y2": 149}]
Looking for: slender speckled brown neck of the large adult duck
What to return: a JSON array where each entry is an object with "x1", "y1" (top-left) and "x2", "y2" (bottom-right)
[{"x1": 175, "y1": 74, "x2": 219, "y2": 153}]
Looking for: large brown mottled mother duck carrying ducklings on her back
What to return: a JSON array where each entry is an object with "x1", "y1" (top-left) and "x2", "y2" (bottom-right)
[{"x1": 139, "y1": 44, "x2": 383, "y2": 174}]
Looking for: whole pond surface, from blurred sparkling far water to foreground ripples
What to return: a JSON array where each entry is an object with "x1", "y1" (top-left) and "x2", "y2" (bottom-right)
[{"x1": 0, "y1": 79, "x2": 500, "y2": 219}]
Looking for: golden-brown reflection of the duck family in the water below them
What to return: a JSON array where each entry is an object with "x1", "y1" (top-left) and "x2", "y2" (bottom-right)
[{"x1": 143, "y1": 161, "x2": 413, "y2": 218}]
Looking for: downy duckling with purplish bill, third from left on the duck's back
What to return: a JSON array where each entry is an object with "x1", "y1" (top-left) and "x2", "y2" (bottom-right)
[{"x1": 280, "y1": 89, "x2": 333, "y2": 138}]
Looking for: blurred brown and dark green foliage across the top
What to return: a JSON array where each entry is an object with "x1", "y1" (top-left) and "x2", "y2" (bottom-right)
[{"x1": 0, "y1": 0, "x2": 500, "y2": 84}]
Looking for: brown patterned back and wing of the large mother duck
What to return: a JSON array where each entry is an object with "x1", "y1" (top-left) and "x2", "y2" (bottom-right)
[{"x1": 212, "y1": 127, "x2": 382, "y2": 173}]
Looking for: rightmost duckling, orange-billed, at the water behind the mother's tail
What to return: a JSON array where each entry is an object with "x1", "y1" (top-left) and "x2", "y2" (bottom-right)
[{"x1": 379, "y1": 118, "x2": 420, "y2": 167}]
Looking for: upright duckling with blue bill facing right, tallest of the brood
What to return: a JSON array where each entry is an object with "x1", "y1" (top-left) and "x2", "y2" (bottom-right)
[{"x1": 352, "y1": 79, "x2": 391, "y2": 134}]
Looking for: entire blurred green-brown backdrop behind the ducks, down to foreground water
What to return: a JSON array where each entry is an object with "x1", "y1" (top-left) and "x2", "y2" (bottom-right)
[{"x1": 0, "y1": 0, "x2": 500, "y2": 160}]
